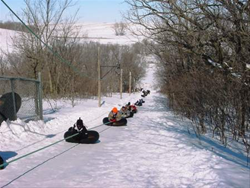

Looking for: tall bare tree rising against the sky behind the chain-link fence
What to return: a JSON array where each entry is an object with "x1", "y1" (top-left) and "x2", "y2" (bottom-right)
[{"x1": 9, "y1": 0, "x2": 79, "y2": 89}]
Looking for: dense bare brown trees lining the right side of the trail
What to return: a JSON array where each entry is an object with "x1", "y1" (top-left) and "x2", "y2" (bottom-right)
[{"x1": 126, "y1": 0, "x2": 250, "y2": 151}]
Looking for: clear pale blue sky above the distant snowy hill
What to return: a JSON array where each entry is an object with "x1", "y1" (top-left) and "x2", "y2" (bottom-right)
[{"x1": 0, "y1": 0, "x2": 128, "y2": 22}]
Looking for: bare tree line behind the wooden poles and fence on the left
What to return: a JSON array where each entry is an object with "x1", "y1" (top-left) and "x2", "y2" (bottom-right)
[{"x1": 0, "y1": 0, "x2": 145, "y2": 101}]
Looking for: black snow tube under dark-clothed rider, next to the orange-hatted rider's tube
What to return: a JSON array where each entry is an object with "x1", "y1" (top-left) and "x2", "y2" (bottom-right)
[{"x1": 64, "y1": 127, "x2": 99, "y2": 144}]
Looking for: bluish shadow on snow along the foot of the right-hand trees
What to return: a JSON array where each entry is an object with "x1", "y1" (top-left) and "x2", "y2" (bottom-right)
[{"x1": 144, "y1": 96, "x2": 250, "y2": 168}]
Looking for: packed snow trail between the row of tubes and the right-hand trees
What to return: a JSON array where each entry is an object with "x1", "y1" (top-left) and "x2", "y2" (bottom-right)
[{"x1": 0, "y1": 92, "x2": 249, "y2": 188}]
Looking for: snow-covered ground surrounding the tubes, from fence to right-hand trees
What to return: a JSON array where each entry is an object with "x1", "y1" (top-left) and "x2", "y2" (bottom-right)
[{"x1": 0, "y1": 64, "x2": 250, "y2": 188}]
